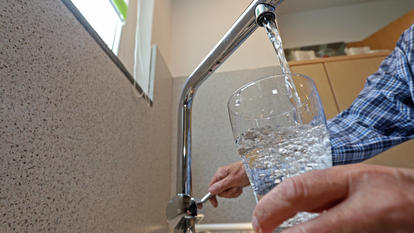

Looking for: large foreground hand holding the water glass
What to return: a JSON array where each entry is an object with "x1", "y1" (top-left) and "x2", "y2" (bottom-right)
[{"x1": 252, "y1": 165, "x2": 414, "y2": 233}]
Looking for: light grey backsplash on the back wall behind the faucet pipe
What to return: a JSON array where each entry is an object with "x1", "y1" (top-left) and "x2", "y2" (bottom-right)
[{"x1": 171, "y1": 66, "x2": 280, "y2": 224}]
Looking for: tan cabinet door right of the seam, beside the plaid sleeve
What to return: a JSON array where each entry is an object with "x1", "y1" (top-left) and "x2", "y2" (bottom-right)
[{"x1": 325, "y1": 56, "x2": 385, "y2": 112}]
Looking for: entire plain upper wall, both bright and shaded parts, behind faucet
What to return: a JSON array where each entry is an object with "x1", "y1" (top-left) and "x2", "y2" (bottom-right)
[{"x1": 170, "y1": 0, "x2": 414, "y2": 77}]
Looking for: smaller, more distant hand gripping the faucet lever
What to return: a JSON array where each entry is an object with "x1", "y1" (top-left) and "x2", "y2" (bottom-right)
[{"x1": 208, "y1": 162, "x2": 250, "y2": 207}]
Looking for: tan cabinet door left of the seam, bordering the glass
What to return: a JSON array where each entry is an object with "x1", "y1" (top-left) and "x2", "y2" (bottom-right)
[{"x1": 291, "y1": 63, "x2": 338, "y2": 119}]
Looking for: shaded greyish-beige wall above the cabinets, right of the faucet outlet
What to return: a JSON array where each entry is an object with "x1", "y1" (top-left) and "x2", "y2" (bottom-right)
[{"x1": 279, "y1": 0, "x2": 414, "y2": 48}]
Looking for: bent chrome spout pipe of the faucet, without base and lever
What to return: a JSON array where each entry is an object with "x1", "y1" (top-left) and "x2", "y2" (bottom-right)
[{"x1": 170, "y1": 0, "x2": 283, "y2": 231}]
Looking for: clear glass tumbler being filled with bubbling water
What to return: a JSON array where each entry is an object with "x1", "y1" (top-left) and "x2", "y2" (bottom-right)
[{"x1": 228, "y1": 74, "x2": 332, "y2": 232}]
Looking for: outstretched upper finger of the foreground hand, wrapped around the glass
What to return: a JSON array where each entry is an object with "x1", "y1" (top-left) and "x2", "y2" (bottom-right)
[{"x1": 252, "y1": 167, "x2": 348, "y2": 233}]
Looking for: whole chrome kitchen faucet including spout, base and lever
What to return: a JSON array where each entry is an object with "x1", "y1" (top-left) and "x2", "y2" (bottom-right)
[{"x1": 167, "y1": 0, "x2": 283, "y2": 233}]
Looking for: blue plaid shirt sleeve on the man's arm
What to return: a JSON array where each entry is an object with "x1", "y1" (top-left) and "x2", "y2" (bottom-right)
[{"x1": 328, "y1": 24, "x2": 414, "y2": 165}]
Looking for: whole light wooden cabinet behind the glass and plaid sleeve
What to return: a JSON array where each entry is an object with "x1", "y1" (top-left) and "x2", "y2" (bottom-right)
[{"x1": 289, "y1": 53, "x2": 414, "y2": 168}]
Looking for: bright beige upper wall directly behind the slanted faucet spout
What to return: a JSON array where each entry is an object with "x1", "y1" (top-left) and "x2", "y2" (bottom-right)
[{"x1": 170, "y1": 0, "x2": 277, "y2": 77}]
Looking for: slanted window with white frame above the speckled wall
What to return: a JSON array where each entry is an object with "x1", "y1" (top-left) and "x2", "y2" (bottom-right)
[{"x1": 62, "y1": 0, "x2": 157, "y2": 100}]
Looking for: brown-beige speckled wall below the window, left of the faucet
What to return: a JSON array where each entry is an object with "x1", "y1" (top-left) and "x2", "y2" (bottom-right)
[{"x1": 0, "y1": 0, "x2": 172, "y2": 233}]
